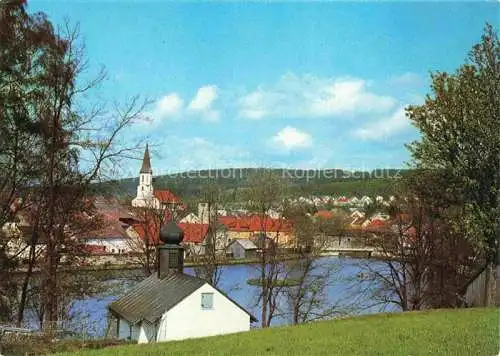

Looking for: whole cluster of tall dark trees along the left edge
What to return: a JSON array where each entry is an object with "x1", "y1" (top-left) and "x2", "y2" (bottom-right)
[{"x1": 0, "y1": 1, "x2": 147, "y2": 328}]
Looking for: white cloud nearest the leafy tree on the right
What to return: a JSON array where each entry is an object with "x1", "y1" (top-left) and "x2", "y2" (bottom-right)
[{"x1": 352, "y1": 108, "x2": 411, "y2": 141}]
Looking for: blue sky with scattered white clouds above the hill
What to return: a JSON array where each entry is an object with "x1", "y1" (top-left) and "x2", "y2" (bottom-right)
[{"x1": 28, "y1": 1, "x2": 499, "y2": 176}]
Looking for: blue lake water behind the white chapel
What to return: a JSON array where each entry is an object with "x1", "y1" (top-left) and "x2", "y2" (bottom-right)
[{"x1": 67, "y1": 256, "x2": 397, "y2": 336}]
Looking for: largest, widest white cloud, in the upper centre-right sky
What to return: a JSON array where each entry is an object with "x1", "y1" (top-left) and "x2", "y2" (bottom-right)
[{"x1": 237, "y1": 74, "x2": 397, "y2": 119}]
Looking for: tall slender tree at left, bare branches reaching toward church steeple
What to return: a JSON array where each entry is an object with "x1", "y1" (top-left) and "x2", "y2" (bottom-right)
[{"x1": 33, "y1": 30, "x2": 145, "y2": 327}]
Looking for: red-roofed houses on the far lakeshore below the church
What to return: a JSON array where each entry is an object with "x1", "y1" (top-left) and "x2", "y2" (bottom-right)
[{"x1": 81, "y1": 198, "x2": 293, "y2": 255}]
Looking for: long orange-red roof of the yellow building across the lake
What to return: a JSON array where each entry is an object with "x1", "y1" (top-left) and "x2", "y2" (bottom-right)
[{"x1": 219, "y1": 215, "x2": 293, "y2": 232}]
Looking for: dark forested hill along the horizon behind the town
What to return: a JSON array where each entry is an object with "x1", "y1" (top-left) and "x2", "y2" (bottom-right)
[{"x1": 96, "y1": 168, "x2": 410, "y2": 201}]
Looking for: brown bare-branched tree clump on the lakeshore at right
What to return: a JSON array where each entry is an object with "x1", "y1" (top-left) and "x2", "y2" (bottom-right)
[{"x1": 361, "y1": 184, "x2": 477, "y2": 311}]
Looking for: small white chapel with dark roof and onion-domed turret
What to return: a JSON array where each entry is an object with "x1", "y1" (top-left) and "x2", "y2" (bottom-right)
[{"x1": 108, "y1": 222, "x2": 256, "y2": 343}]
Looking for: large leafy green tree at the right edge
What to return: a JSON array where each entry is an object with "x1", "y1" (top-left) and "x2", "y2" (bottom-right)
[{"x1": 407, "y1": 24, "x2": 500, "y2": 304}]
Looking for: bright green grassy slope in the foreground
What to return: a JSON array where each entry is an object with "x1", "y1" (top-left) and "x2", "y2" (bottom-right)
[{"x1": 57, "y1": 309, "x2": 500, "y2": 356}]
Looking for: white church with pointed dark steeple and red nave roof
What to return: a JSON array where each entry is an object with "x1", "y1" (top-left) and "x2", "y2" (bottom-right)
[{"x1": 132, "y1": 145, "x2": 184, "y2": 211}]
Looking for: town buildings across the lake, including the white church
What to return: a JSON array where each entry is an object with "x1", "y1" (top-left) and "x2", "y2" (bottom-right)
[{"x1": 72, "y1": 147, "x2": 394, "y2": 261}]
